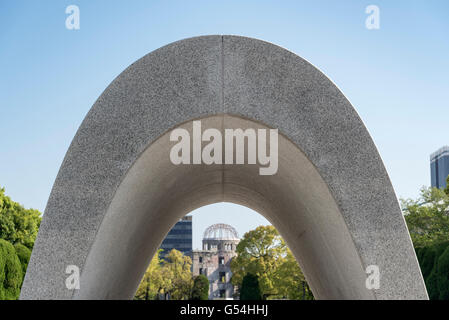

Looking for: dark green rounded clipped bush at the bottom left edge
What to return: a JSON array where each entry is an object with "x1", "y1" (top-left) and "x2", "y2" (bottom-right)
[{"x1": 0, "y1": 239, "x2": 23, "y2": 300}]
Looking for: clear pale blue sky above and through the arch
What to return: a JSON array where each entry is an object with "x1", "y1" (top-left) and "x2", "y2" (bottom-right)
[{"x1": 0, "y1": 0, "x2": 449, "y2": 246}]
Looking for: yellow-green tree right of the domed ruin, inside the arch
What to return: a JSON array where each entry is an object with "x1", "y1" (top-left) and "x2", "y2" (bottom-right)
[{"x1": 231, "y1": 226, "x2": 313, "y2": 299}]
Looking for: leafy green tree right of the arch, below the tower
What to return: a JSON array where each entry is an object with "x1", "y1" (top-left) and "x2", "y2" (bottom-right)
[{"x1": 401, "y1": 188, "x2": 449, "y2": 248}]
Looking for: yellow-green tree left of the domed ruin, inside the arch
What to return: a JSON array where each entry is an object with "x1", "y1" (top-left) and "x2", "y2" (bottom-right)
[{"x1": 135, "y1": 249, "x2": 193, "y2": 300}]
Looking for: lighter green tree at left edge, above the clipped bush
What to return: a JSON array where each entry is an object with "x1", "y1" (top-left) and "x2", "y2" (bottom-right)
[{"x1": 0, "y1": 188, "x2": 41, "y2": 249}]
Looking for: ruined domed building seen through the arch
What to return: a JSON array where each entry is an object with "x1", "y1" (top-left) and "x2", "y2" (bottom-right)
[{"x1": 191, "y1": 223, "x2": 240, "y2": 300}]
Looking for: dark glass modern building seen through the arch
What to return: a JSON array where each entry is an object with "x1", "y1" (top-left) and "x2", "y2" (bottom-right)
[{"x1": 160, "y1": 216, "x2": 192, "y2": 257}]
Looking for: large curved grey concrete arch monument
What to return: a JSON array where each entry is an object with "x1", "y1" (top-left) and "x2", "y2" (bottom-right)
[{"x1": 21, "y1": 36, "x2": 427, "y2": 299}]
